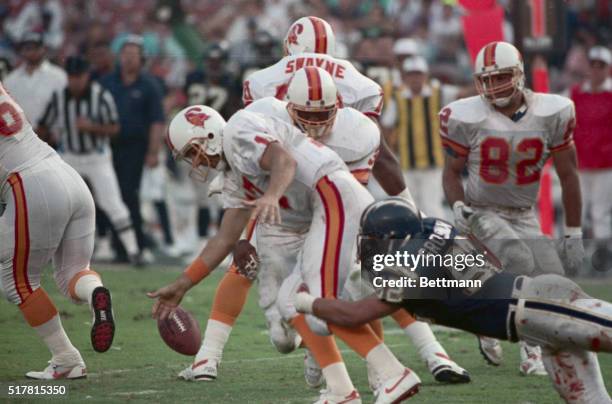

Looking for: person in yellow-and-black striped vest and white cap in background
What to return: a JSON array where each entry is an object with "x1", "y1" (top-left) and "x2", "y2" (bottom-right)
[{"x1": 381, "y1": 56, "x2": 462, "y2": 217}]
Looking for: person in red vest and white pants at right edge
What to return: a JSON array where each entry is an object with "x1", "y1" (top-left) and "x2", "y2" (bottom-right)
[{"x1": 570, "y1": 46, "x2": 612, "y2": 266}]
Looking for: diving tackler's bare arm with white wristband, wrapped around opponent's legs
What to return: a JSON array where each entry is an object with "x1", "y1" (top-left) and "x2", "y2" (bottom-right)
[{"x1": 296, "y1": 292, "x2": 400, "y2": 327}]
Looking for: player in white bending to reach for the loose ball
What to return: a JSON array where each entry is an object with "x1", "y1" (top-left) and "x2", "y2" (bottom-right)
[{"x1": 149, "y1": 106, "x2": 420, "y2": 403}]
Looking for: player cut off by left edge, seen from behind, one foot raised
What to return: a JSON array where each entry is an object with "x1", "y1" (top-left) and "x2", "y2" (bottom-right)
[{"x1": 0, "y1": 85, "x2": 115, "y2": 380}]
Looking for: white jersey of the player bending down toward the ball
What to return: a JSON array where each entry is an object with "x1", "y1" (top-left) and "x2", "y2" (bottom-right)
[{"x1": 222, "y1": 110, "x2": 348, "y2": 230}]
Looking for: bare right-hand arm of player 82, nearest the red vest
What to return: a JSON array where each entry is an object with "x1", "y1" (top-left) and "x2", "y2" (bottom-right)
[{"x1": 552, "y1": 146, "x2": 582, "y2": 227}]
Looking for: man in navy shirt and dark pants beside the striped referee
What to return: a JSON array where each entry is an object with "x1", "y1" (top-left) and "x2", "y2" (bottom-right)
[{"x1": 100, "y1": 35, "x2": 165, "y2": 262}]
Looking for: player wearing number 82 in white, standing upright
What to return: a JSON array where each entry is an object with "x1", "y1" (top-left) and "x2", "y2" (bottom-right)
[{"x1": 440, "y1": 42, "x2": 584, "y2": 374}]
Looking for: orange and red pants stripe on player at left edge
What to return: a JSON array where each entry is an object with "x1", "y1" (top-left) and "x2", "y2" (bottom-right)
[{"x1": 8, "y1": 173, "x2": 32, "y2": 303}]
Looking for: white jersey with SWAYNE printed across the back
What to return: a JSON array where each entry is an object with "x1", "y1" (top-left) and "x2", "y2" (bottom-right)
[{"x1": 242, "y1": 53, "x2": 383, "y2": 118}]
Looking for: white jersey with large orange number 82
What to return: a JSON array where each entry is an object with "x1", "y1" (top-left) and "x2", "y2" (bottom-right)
[{"x1": 440, "y1": 90, "x2": 575, "y2": 208}]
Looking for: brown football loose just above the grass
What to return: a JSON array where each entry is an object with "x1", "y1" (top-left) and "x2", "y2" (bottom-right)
[{"x1": 157, "y1": 306, "x2": 202, "y2": 356}]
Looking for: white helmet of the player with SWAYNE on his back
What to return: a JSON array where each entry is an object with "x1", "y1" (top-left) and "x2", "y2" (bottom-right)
[{"x1": 284, "y1": 16, "x2": 336, "y2": 55}]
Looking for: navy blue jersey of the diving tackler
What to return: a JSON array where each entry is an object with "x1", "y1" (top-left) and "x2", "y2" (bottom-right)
[{"x1": 377, "y1": 218, "x2": 517, "y2": 339}]
